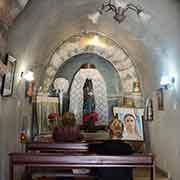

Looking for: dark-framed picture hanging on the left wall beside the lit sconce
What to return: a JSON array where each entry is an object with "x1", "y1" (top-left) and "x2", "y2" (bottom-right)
[{"x1": 1, "y1": 54, "x2": 16, "y2": 96}]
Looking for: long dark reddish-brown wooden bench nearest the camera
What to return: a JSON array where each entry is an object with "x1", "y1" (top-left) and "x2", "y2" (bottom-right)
[{"x1": 9, "y1": 152, "x2": 155, "y2": 180}]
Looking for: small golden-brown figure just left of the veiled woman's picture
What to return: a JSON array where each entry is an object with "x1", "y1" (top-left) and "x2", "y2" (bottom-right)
[{"x1": 109, "y1": 116, "x2": 124, "y2": 139}]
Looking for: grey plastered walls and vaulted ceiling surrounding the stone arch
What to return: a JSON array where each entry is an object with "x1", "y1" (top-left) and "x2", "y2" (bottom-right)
[{"x1": 0, "y1": 0, "x2": 180, "y2": 180}]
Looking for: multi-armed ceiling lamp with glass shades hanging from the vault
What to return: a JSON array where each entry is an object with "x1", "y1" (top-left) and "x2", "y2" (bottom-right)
[{"x1": 88, "y1": 0, "x2": 151, "y2": 24}]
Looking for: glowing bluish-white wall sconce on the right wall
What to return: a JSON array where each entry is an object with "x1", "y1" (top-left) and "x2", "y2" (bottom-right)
[{"x1": 160, "y1": 76, "x2": 175, "y2": 90}]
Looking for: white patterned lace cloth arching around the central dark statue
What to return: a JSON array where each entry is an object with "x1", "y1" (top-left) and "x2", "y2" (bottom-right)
[{"x1": 69, "y1": 69, "x2": 108, "y2": 125}]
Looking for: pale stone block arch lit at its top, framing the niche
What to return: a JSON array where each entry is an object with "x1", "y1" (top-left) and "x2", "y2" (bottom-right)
[{"x1": 43, "y1": 32, "x2": 139, "y2": 95}]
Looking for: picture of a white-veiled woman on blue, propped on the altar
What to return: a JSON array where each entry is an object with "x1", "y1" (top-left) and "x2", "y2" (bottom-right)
[{"x1": 113, "y1": 107, "x2": 144, "y2": 141}]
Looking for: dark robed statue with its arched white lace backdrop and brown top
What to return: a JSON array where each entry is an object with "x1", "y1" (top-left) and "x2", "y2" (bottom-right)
[{"x1": 69, "y1": 64, "x2": 108, "y2": 126}]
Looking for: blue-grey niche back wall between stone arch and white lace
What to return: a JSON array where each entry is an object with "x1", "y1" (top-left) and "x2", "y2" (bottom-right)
[{"x1": 54, "y1": 53, "x2": 122, "y2": 96}]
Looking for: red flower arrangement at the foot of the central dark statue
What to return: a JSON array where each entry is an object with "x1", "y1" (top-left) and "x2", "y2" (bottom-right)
[{"x1": 83, "y1": 112, "x2": 98, "y2": 132}]
